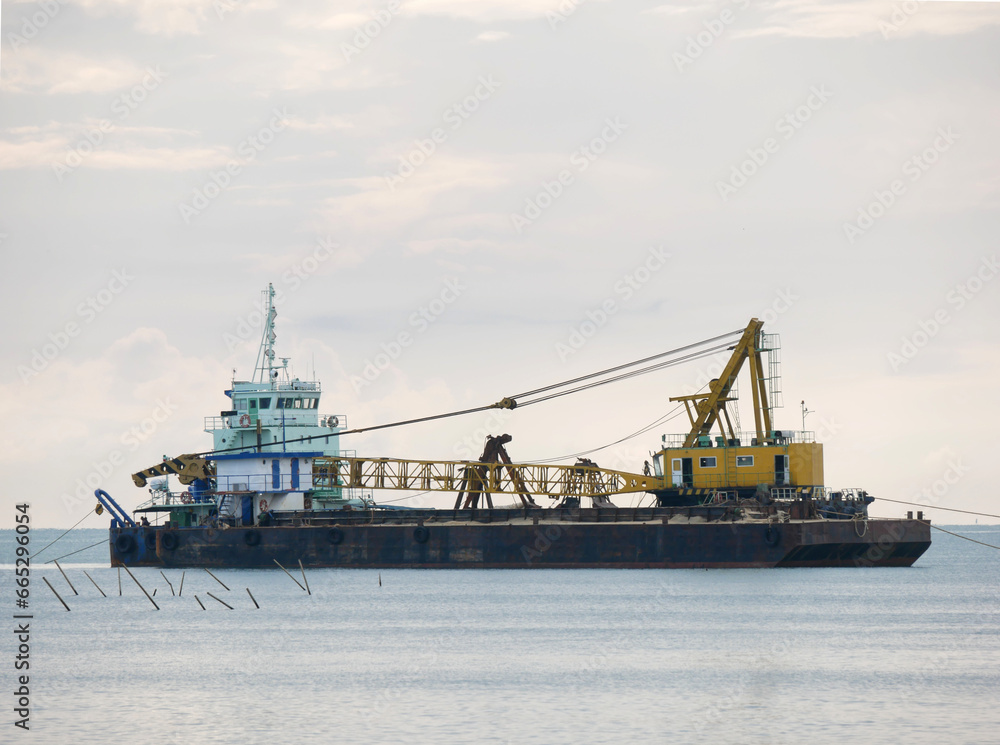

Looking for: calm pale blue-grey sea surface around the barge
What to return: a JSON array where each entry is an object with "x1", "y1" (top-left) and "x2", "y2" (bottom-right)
[{"x1": 0, "y1": 526, "x2": 1000, "y2": 745}]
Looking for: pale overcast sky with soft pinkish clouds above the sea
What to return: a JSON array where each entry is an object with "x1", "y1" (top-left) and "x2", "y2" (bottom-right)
[{"x1": 0, "y1": 0, "x2": 1000, "y2": 528}]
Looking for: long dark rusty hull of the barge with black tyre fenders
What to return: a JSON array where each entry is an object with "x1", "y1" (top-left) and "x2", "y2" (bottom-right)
[{"x1": 110, "y1": 508, "x2": 931, "y2": 569}]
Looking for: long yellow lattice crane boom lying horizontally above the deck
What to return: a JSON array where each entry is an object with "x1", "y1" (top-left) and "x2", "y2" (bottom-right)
[{"x1": 313, "y1": 457, "x2": 666, "y2": 498}]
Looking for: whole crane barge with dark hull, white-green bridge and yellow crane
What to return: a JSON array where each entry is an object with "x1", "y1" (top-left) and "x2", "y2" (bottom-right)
[{"x1": 96, "y1": 287, "x2": 931, "y2": 568}]
